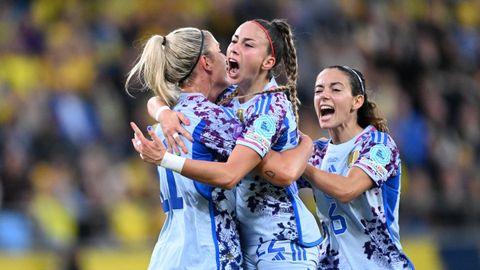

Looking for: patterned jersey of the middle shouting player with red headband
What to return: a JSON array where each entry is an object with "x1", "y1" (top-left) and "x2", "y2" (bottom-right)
[{"x1": 225, "y1": 80, "x2": 322, "y2": 248}]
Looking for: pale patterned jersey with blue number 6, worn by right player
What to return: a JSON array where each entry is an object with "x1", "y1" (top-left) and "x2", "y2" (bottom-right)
[{"x1": 309, "y1": 126, "x2": 413, "y2": 269}]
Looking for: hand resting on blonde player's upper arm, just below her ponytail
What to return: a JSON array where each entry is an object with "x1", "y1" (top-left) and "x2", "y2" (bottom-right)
[{"x1": 159, "y1": 110, "x2": 193, "y2": 154}]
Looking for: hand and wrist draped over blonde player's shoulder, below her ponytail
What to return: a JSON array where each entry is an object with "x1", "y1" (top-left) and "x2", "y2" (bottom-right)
[{"x1": 147, "y1": 96, "x2": 193, "y2": 154}]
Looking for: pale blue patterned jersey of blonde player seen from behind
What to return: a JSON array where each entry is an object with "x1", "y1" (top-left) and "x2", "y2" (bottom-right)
[{"x1": 148, "y1": 93, "x2": 242, "y2": 270}]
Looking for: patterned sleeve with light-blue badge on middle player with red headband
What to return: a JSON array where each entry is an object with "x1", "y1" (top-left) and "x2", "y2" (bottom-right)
[{"x1": 237, "y1": 93, "x2": 290, "y2": 158}]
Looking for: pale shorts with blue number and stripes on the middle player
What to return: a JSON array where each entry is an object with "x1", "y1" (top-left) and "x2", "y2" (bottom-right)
[{"x1": 243, "y1": 240, "x2": 320, "y2": 270}]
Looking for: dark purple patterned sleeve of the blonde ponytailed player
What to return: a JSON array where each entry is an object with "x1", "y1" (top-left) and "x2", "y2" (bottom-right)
[{"x1": 178, "y1": 96, "x2": 242, "y2": 158}]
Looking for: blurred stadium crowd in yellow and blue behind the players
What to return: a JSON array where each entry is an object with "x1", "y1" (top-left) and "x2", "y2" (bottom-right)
[{"x1": 0, "y1": 0, "x2": 480, "y2": 268}]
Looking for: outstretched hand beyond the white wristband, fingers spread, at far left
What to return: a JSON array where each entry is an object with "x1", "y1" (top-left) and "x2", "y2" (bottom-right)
[{"x1": 130, "y1": 122, "x2": 167, "y2": 166}]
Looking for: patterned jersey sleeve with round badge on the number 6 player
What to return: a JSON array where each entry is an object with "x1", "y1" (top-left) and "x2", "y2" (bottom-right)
[{"x1": 352, "y1": 131, "x2": 400, "y2": 187}]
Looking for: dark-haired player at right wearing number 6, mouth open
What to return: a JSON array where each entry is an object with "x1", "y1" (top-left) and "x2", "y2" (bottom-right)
[{"x1": 305, "y1": 66, "x2": 413, "y2": 269}]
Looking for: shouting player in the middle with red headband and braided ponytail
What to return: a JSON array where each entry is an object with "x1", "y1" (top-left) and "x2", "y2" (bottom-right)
[{"x1": 134, "y1": 20, "x2": 322, "y2": 269}]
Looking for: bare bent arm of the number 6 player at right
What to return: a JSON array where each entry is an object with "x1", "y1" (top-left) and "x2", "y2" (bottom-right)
[{"x1": 304, "y1": 164, "x2": 374, "y2": 203}]
